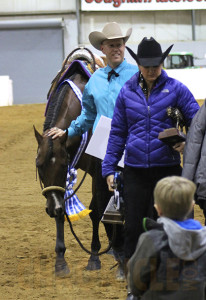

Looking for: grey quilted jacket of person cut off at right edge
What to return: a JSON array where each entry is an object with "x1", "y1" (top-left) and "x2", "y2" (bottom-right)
[{"x1": 182, "y1": 102, "x2": 206, "y2": 200}]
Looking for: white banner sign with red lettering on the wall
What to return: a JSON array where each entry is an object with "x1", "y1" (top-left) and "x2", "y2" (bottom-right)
[{"x1": 81, "y1": 0, "x2": 206, "y2": 11}]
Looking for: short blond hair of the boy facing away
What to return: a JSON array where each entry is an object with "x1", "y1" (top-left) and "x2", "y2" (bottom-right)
[{"x1": 154, "y1": 176, "x2": 196, "y2": 220}]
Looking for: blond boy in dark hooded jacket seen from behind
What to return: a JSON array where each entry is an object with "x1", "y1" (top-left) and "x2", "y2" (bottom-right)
[{"x1": 127, "y1": 176, "x2": 206, "y2": 300}]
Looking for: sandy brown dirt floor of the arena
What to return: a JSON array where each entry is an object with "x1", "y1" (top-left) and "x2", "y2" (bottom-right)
[{"x1": 0, "y1": 104, "x2": 203, "y2": 300}]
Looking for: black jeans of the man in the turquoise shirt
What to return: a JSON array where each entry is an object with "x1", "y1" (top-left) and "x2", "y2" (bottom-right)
[{"x1": 95, "y1": 158, "x2": 124, "y2": 252}]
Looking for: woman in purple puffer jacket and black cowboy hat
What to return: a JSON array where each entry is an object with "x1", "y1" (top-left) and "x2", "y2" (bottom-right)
[{"x1": 102, "y1": 37, "x2": 199, "y2": 288}]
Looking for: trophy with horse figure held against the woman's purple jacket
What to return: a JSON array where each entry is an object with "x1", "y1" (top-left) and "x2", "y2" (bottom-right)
[{"x1": 158, "y1": 106, "x2": 186, "y2": 146}]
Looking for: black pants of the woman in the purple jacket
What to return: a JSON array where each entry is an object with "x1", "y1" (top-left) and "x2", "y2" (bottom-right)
[{"x1": 124, "y1": 165, "x2": 182, "y2": 258}]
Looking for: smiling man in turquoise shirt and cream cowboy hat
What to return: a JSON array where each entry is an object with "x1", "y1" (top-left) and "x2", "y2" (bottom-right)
[{"x1": 49, "y1": 22, "x2": 138, "y2": 279}]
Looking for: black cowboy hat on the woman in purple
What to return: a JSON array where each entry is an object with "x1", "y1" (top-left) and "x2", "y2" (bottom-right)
[{"x1": 126, "y1": 37, "x2": 173, "y2": 67}]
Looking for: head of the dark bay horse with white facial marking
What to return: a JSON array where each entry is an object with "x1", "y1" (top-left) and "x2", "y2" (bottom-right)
[{"x1": 34, "y1": 127, "x2": 68, "y2": 218}]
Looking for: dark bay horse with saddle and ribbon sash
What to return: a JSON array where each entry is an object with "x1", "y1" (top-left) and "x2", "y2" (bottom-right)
[{"x1": 34, "y1": 48, "x2": 104, "y2": 276}]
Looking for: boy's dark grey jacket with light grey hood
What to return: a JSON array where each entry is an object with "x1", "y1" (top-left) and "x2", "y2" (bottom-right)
[{"x1": 128, "y1": 217, "x2": 206, "y2": 300}]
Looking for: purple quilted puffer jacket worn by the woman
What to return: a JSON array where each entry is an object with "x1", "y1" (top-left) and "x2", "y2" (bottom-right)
[{"x1": 102, "y1": 70, "x2": 199, "y2": 176}]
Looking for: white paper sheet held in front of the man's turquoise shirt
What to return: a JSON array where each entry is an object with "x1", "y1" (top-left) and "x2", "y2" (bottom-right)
[{"x1": 85, "y1": 116, "x2": 124, "y2": 168}]
